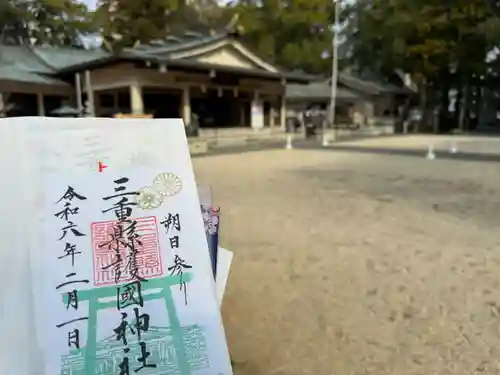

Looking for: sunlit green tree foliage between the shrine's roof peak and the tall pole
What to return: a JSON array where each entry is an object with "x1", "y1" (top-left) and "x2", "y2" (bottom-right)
[{"x1": 226, "y1": 0, "x2": 334, "y2": 73}]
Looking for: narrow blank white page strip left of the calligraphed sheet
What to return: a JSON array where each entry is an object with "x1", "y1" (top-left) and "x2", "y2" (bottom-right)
[{"x1": 0, "y1": 119, "x2": 40, "y2": 375}]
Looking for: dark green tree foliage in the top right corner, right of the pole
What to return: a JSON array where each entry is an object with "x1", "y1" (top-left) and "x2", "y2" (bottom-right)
[{"x1": 348, "y1": 0, "x2": 499, "y2": 134}]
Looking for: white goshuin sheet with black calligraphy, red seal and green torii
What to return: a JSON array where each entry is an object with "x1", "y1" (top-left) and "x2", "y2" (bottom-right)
[{"x1": 2, "y1": 118, "x2": 232, "y2": 375}]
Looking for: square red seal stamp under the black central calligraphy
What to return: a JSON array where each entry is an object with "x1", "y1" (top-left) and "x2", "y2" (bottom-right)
[{"x1": 91, "y1": 216, "x2": 163, "y2": 286}]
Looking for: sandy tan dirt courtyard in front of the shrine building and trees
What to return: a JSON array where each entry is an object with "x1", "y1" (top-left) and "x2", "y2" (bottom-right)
[{"x1": 194, "y1": 141, "x2": 500, "y2": 375}]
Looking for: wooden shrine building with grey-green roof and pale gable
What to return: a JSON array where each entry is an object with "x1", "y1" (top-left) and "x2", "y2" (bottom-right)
[{"x1": 0, "y1": 32, "x2": 311, "y2": 129}]
